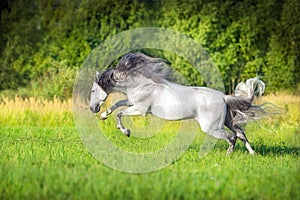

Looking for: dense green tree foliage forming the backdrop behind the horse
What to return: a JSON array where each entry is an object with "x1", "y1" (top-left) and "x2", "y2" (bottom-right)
[{"x1": 0, "y1": 0, "x2": 300, "y2": 98}]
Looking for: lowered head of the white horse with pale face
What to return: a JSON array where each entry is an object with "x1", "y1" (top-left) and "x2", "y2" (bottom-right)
[{"x1": 90, "y1": 70, "x2": 114, "y2": 113}]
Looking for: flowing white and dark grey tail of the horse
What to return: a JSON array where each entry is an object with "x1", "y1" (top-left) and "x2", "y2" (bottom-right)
[{"x1": 224, "y1": 77, "x2": 272, "y2": 127}]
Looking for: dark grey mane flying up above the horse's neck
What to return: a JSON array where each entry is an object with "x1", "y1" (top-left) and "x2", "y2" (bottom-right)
[{"x1": 115, "y1": 52, "x2": 172, "y2": 82}]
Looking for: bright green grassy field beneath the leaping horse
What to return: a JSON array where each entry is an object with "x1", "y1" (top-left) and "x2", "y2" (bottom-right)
[{"x1": 0, "y1": 95, "x2": 300, "y2": 199}]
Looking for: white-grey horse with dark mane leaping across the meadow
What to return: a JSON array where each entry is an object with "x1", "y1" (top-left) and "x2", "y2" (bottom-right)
[{"x1": 90, "y1": 53, "x2": 265, "y2": 154}]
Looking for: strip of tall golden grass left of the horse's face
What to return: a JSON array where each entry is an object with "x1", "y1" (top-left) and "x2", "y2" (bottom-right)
[{"x1": 0, "y1": 96, "x2": 73, "y2": 127}]
